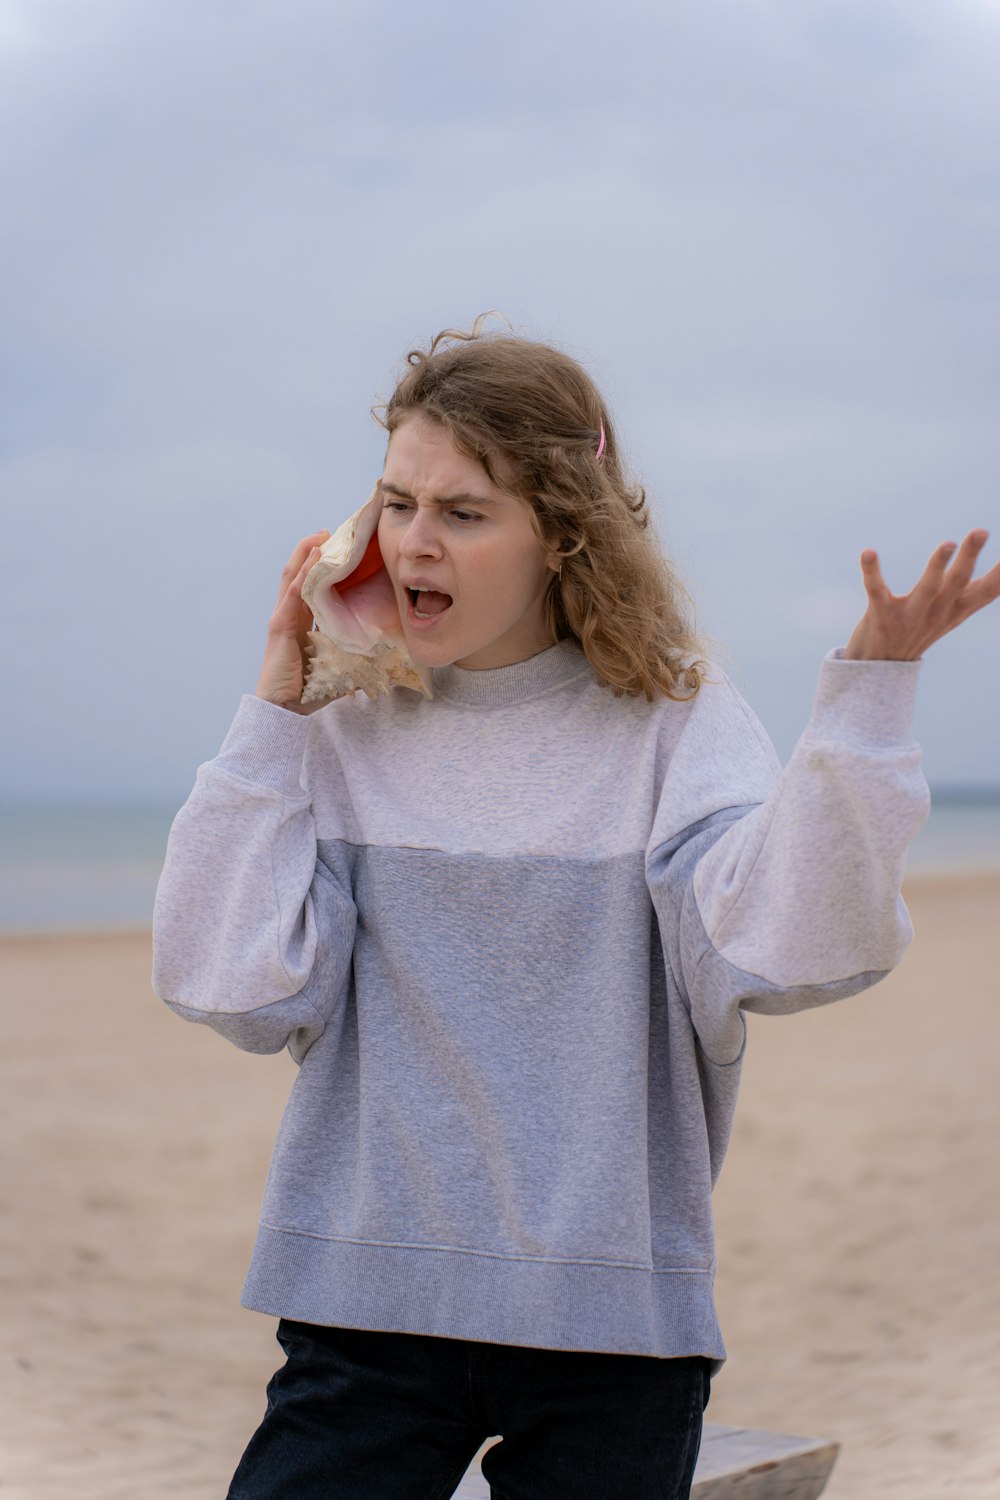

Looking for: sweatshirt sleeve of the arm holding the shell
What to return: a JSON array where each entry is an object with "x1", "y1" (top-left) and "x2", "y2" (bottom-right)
[{"x1": 153, "y1": 693, "x2": 357, "y2": 1061}]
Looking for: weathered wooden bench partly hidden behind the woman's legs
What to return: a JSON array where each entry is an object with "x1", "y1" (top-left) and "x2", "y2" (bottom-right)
[{"x1": 456, "y1": 1422, "x2": 840, "y2": 1500}]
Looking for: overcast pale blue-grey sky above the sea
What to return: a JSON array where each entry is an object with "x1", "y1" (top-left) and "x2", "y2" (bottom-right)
[{"x1": 0, "y1": 0, "x2": 1000, "y2": 801}]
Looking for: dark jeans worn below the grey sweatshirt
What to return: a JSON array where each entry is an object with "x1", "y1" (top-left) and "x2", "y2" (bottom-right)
[{"x1": 229, "y1": 1320, "x2": 709, "y2": 1500}]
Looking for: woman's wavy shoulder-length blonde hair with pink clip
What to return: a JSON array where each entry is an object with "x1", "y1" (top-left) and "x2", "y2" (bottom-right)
[{"x1": 373, "y1": 314, "x2": 705, "y2": 702}]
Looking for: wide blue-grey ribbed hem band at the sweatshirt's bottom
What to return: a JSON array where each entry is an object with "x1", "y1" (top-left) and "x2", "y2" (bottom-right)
[{"x1": 241, "y1": 1226, "x2": 726, "y2": 1368}]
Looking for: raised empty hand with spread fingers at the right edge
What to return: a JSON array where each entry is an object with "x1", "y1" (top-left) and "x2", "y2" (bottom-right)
[{"x1": 844, "y1": 531, "x2": 1000, "y2": 662}]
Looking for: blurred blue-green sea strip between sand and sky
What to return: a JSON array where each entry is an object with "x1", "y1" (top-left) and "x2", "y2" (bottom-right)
[{"x1": 0, "y1": 786, "x2": 1000, "y2": 935}]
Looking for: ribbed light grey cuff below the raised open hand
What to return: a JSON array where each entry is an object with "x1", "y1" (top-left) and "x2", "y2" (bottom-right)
[{"x1": 807, "y1": 647, "x2": 921, "y2": 750}]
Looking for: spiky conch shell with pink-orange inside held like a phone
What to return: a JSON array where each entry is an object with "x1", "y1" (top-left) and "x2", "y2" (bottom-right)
[{"x1": 301, "y1": 483, "x2": 433, "y2": 704}]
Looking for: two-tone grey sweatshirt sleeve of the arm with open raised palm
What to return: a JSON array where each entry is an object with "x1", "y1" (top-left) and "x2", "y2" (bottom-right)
[{"x1": 646, "y1": 653, "x2": 930, "y2": 1065}]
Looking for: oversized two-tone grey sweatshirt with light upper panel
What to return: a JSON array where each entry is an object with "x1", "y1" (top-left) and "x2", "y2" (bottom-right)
[{"x1": 153, "y1": 645, "x2": 928, "y2": 1365}]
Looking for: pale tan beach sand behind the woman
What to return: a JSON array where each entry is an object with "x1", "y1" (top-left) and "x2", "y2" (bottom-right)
[{"x1": 0, "y1": 875, "x2": 1000, "y2": 1500}]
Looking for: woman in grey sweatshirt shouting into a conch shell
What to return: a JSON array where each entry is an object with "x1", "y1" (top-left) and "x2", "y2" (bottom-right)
[{"x1": 153, "y1": 313, "x2": 1000, "y2": 1500}]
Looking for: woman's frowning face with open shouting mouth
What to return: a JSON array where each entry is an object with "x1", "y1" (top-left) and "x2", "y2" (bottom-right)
[{"x1": 378, "y1": 416, "x2": 559, "y2": 669}]
